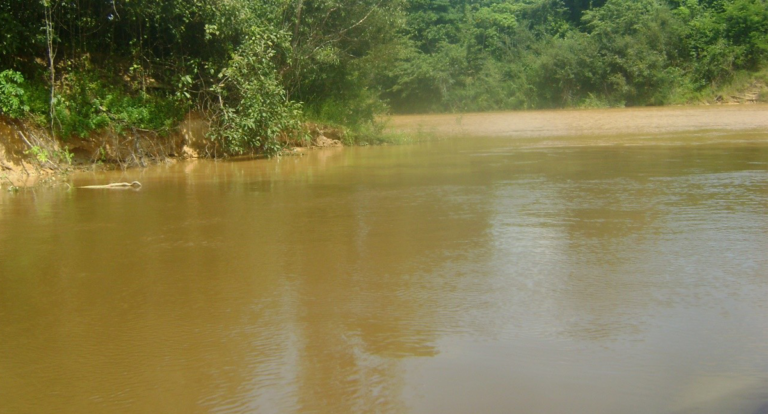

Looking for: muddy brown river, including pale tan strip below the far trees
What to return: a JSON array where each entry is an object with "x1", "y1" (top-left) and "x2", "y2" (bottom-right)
[{"x1": 0, "y1": 105, "x2": 768, "y2": 414}]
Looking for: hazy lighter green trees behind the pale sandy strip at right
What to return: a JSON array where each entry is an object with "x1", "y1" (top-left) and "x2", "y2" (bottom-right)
[{"x1": 384, "y1": 0, "x2": 768, "y2": 111}]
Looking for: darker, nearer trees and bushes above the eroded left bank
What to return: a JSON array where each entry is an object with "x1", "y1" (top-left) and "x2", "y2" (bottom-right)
[{"x1": 0, "y1": 0, "x2": 403, "y2": 153}]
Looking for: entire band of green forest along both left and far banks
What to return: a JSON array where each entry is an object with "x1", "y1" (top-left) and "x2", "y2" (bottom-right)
[{"x1": 0, "y1": 0, "x2": 768, "y2": 154}]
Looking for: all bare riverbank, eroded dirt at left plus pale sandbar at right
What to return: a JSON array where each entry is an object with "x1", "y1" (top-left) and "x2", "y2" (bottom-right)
[{"x1": 0, "y1": 103, "x2": 768, "y2": 188}]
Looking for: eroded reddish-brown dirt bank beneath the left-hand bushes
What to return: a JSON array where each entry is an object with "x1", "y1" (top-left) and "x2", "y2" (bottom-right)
[{"x1": 0, "y1": 113, "x2": 344, "y2": 188}]
